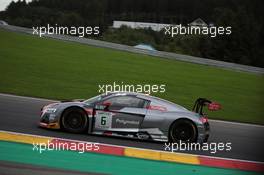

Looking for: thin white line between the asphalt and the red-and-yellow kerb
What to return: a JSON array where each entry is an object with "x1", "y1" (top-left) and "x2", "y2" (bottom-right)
[{"x1": 0, "y1": 130, "x2": 264, "y2": 164}]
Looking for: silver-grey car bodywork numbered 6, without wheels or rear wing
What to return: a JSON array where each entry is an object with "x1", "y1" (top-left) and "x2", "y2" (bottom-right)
[{"x1": 40, "y1": 92, "x2": 209, "y2": 143}]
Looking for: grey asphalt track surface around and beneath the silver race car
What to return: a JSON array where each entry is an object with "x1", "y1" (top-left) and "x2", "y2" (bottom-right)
[{"x1": 0, "y1": 94, "x2": 264, "y2": 162}]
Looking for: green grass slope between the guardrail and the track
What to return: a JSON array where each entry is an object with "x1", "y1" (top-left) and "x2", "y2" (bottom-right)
[{"x1": 0, "y1": 30, "x2": 264, "y2": 124}]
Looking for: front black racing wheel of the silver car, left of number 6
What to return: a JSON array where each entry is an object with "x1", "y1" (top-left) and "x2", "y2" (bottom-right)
[{"x1": 61, "y1": 108, "x2": 88, "y2": 133}]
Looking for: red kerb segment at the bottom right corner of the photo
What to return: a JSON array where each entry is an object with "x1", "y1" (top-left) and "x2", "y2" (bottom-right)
[{"x1": 198, "y1": 156, "x2": 264, "y2": 172}]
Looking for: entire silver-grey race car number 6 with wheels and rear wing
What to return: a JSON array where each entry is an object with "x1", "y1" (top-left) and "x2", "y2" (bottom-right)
[{"x1": 39, "y1": 92, "x2": 221, "y2": 143}]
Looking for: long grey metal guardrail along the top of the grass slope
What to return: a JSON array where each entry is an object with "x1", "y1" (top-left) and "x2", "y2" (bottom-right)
[{"x1": 0, "y1": 25, "x2": 264, "y2": 74}]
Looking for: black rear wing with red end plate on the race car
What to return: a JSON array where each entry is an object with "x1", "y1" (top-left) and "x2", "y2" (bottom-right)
[{"x1": 192, "y1": 98, "x2": 222, "y2": 115}]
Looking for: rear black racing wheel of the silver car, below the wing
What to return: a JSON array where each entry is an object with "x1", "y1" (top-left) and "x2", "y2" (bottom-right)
[{"x1": 169, "y1": 119, "x2": 197, "y2": 143}]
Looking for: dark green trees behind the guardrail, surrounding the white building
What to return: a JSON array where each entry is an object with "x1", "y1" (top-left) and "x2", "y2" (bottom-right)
[{"x1": 0, "y1": 0, "x2": 264, "y2": 67}]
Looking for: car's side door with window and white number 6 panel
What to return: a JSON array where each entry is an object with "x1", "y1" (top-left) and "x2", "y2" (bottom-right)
[{"x1": 94, "y1": 95, "x2": 148, "y2": 132}]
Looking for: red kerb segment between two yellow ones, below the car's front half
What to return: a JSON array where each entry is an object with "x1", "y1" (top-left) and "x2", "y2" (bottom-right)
[{"x1": 50, "y1": 139, "x2": 124, "y2": 156}]
